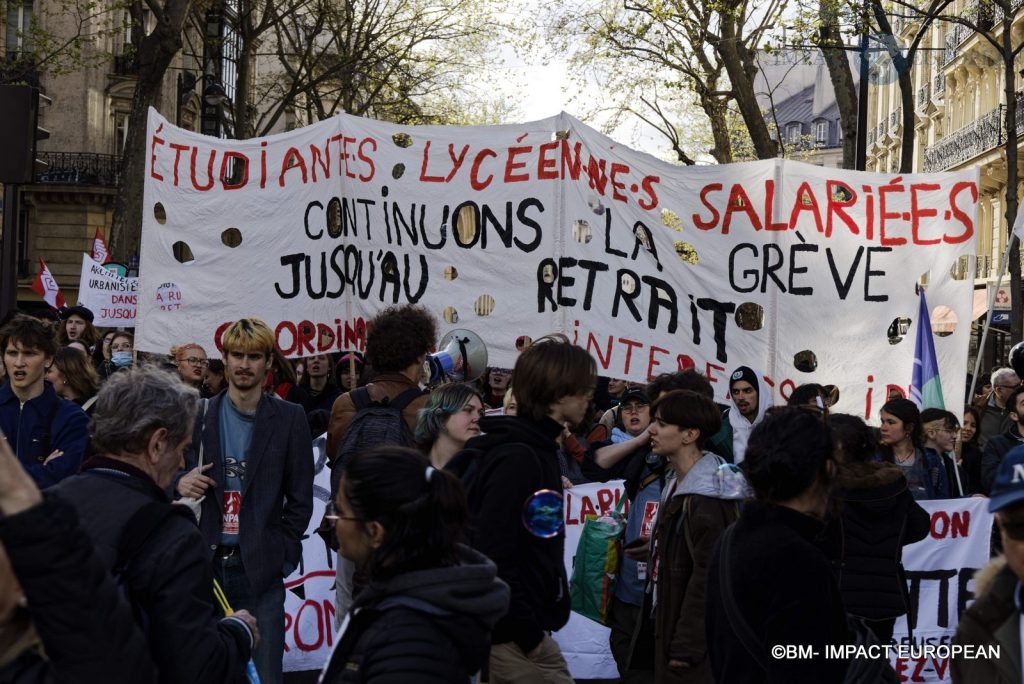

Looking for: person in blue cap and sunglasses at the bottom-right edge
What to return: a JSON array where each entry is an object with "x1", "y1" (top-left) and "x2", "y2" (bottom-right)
[{"x1": 949, "y1": 446, "x2": 1024, "y2": 684}]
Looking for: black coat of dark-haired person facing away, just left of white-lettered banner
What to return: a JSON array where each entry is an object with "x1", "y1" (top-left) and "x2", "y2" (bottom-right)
[{"x1": 705, "y1": 502, "x2": 850, "y2": 684}]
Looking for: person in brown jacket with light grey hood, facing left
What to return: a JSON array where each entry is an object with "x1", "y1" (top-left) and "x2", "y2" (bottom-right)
[{"x1": 650, "y1": 389, "x2": 745, "y2": 684}]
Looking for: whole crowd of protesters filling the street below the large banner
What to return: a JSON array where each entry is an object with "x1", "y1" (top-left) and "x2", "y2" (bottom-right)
[{"x1": 0, "y1": 306, "x2": 1024, "y2": 684}]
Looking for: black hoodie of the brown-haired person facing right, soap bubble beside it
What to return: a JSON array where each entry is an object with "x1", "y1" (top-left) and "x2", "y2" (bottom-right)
[{"x1": 446, "y1": 416, "x2": 569, "y2": 652}]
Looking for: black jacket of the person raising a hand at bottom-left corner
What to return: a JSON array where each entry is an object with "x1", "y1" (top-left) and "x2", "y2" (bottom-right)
[{"x1": 0, "y1": 497, "x2": 157, "y2": 684}]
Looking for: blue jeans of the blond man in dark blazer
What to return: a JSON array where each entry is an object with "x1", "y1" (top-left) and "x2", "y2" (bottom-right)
[{"x1": 213, "y1": 553, "x2": 285, "y2": 684}]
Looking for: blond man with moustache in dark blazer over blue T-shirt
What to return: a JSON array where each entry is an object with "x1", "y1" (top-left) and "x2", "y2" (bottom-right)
[{"x1": 177, "y1": 318, "x2": 313, "y2": 684}]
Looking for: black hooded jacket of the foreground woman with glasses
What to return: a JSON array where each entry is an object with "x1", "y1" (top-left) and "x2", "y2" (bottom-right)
[{"x1": 324, "y1": 547, "x2": 509, "y2": 684}]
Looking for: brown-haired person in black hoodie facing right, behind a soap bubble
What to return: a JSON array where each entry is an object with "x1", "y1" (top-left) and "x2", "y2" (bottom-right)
[{"x1": 447, "y1": 335, "x2": 597, "y2": 684}]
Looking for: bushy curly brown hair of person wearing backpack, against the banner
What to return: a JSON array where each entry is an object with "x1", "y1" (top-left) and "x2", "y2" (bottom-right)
[{"x1": 366, "y1": 304, "x2": 437, "y2": 373}]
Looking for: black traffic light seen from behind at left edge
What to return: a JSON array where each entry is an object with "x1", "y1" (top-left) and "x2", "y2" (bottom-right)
[{"x1": 0, "y1": 85, "x2": 50, "y2": 183}]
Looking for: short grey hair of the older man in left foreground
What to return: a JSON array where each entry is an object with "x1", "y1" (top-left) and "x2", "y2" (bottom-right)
[{"x1": 90, "y1": 366, "x2": 199, "y2": 455}]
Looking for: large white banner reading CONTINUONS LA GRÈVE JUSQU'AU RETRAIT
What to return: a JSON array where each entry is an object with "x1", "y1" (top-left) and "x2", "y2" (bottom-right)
[{"x1": 136, "y1": 111, "x2": 979, "y2": 419}]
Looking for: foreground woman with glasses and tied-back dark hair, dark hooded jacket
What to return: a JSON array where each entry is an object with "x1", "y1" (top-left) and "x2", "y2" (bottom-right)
[{"x1": 319, "y1": 446, "x2": 509, "y2": 684}]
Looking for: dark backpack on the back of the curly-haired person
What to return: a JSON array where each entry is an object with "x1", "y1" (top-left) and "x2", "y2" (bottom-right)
[{"x1": 316, "y1": 387, "x2": 426, "y2": 551}]
